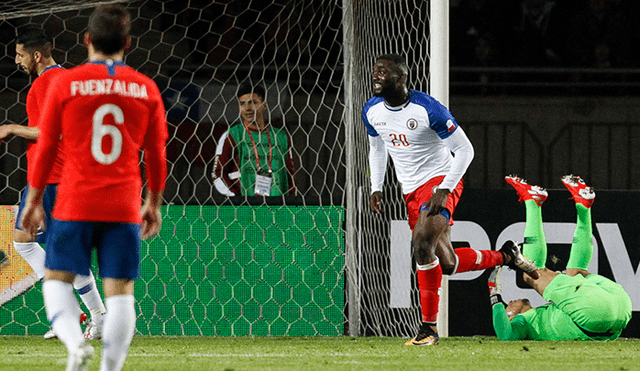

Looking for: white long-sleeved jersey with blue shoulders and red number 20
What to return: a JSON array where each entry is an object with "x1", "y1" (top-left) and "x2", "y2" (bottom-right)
[{"x1": 362, "y1": 90, "x2": 473, "y2": 194}]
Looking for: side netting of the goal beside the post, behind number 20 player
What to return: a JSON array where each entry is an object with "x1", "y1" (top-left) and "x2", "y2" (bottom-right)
[{"x1": 353, "y1": 0, "x2": 429, "y2": 336}]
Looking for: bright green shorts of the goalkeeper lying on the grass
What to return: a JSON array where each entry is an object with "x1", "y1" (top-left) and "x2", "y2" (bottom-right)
[{"x1": 543, "y1": 274, "x2": 632, "y2": 338}]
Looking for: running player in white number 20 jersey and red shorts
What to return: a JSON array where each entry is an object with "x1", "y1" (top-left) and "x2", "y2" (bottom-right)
[{"x1": 362, "y1": 54, "x2": 537, "y2": 345}]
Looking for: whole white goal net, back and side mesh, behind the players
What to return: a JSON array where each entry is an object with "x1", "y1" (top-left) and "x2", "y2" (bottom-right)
[{"x1": 0, "y1": 0, "x2": 429, "y2": 336}]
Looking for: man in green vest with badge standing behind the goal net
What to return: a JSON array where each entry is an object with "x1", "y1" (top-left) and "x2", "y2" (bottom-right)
[{"x1": 212, "y1": 83, "x2": 296, "y2": 197}]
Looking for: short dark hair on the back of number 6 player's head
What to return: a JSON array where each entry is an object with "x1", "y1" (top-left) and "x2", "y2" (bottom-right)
[{"x1": 87, "y1": 4, "x2": 131, "y2": 55}]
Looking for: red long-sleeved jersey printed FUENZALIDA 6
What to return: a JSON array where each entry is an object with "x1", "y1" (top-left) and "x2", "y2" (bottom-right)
[{"x1": 32, "y1": 61, "x2": 168, "y2": 223}]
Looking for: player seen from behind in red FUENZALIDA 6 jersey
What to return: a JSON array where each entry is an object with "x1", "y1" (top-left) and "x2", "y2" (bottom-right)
[{"x1": 22, "y1": 5, "x2": 168, "y2": 370}]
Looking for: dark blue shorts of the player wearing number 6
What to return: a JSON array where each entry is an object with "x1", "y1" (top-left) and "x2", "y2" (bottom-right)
[{"x1": 44, "y1": 219, "x2": 140, "y2": 280}]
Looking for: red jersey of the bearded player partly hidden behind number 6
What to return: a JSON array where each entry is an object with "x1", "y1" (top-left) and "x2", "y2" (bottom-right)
[{"x1": 27, "y1": 64, "x2": 64, "y2": 184}]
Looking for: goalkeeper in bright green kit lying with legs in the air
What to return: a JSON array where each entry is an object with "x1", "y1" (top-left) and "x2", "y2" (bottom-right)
[{"x1": 489, "y1": 175, "x2": 632, "y2": 340}]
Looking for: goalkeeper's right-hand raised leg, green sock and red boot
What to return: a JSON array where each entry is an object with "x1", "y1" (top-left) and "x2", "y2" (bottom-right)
[{"x1": 562, "y1": 175, "x2": 596, "y2": 270}]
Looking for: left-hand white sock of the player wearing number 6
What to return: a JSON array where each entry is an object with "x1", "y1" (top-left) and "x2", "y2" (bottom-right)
[{"x1": 42, "y1": 280, "x2": 84, "y2": 352}]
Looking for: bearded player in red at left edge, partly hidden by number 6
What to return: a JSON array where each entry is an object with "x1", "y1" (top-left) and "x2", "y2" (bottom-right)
[{"x1": 0, "y1": 27, "x2": 105, "y2": 340}]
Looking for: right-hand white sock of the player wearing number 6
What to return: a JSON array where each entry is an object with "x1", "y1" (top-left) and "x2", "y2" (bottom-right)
[{"x1": 100, "y1": 295, "x2": 136, "y2": 371}]
